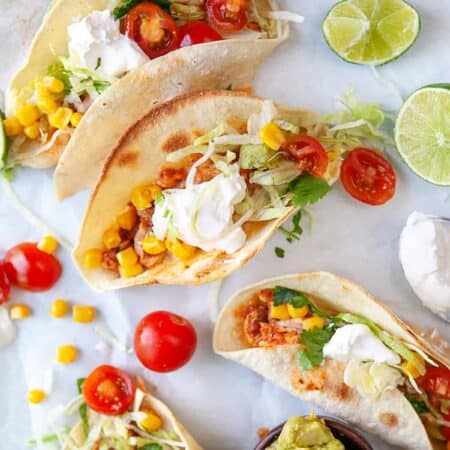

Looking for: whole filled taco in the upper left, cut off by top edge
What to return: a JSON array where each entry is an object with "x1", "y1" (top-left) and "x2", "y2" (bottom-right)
[{"x1": 4, "y1": 0, "x2": 289, "y2": 192}]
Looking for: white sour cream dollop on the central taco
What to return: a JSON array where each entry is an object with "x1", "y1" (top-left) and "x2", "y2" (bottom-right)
[{"x1": 153, "y1": 164, "x2": 247, "y2": 254}]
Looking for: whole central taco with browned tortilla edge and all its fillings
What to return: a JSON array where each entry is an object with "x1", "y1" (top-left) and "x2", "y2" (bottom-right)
[{"x1": 73, "y1": 91, "x2": 354, "y2": 290}]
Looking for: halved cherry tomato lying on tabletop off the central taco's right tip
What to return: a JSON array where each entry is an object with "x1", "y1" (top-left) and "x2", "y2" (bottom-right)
[{"x1": 341, "y1": 147, "x2": 396, "y2": 205}]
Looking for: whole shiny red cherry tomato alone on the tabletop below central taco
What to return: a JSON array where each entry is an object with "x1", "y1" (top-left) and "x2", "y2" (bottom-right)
[{"x1": 134, "y1": 311, "x2": 197, "y2": 372}]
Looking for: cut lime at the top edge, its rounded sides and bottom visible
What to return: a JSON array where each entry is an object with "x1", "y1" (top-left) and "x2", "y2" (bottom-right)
[{"x1": 322, "y1": 0, "x2": 420, "y2": 66}]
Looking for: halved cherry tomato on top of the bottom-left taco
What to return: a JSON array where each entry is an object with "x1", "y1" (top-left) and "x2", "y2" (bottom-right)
[{"x1": 83, "y1": 365, "x2": 136, "y2": 416}]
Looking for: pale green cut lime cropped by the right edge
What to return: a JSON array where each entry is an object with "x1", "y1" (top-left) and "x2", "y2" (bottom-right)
[{"x1": 395, "y1": 84, "x2": 450, "y2": 186}]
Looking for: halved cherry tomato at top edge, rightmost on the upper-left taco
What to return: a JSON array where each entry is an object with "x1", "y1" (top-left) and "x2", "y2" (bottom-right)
[{"x1": 206, "y1": 0, "x2": 248, "y2": 31}]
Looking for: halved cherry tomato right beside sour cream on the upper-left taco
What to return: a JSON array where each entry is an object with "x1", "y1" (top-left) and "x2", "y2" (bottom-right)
[{"x1": 125, "y1": 2, "x2": 180, "y2": 58}]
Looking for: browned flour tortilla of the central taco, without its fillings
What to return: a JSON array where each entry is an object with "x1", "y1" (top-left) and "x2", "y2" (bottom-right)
[{"x1": 73, "y1": 91, "x2": 315, "y2": 291}]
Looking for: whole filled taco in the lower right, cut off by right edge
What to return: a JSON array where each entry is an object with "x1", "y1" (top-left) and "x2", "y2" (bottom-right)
[{"x1": 213, "y1": 272, "x2": 450, "y2": 450}]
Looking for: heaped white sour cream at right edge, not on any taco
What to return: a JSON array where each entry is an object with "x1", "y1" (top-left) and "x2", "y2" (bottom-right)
[{"x1": 399, "y1": 211, "x2": 450, "y2": 320}]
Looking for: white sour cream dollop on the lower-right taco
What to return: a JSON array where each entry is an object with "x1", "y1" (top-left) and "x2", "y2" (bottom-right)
[{"x1": 323, "y1": 324, "x2": 400, "y2": 364}]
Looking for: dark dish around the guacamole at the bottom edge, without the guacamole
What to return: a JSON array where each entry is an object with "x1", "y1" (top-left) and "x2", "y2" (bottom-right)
[{"x1": 255, "y1": 416, "x2": 373, "y2": 450}]
